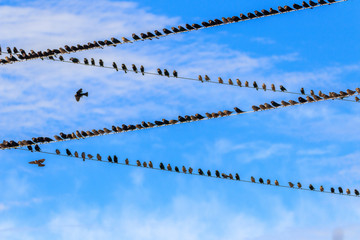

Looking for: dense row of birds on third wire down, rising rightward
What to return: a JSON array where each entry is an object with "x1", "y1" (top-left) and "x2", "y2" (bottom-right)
[{"x1": 0, "y1": 88, "x2": 360, "y2": 149}]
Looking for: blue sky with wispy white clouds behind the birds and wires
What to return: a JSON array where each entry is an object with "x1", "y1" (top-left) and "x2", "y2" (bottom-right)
[{"x1": 0, "y1": 0, "x2": 360, "y2": 240}]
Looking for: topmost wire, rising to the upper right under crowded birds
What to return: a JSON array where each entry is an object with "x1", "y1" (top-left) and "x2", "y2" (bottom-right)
[{"x1": 0, "y1": 0, "x2": 347, "y2": 64}]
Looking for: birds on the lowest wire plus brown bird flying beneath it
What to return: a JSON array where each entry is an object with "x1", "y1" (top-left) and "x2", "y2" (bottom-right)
[{"x1": 21, "y1": 149, "x2": 359, "y2": 196}]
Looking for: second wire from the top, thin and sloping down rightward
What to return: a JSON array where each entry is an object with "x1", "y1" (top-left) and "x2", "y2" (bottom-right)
[{"x1": 46, "y1": 58, "x2": 358, "y2": 103}]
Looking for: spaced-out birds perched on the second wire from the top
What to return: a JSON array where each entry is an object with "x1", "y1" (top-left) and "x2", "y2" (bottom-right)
[{"x1": 47, "y1": 56, "x2": 360, "y2": 102}]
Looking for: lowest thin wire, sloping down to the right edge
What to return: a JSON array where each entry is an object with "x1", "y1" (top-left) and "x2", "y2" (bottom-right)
[{"x1": 17, "y1": 148, "x2": 358, "y2": 197}]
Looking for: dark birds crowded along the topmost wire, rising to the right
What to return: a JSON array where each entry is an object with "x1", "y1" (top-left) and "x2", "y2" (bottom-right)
[{"x1": 0, "y1": 0, "x2": 347, "y2": 64}]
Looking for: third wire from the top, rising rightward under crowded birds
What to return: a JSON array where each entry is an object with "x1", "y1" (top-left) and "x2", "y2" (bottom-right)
[{"x1": 0, "y1": 90, "x2": 359, "y2": 150}]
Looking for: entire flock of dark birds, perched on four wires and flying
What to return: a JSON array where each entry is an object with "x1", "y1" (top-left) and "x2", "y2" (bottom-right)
[{"x1": 0, "y1": 0, "x2": 354, "y2": 196}]
